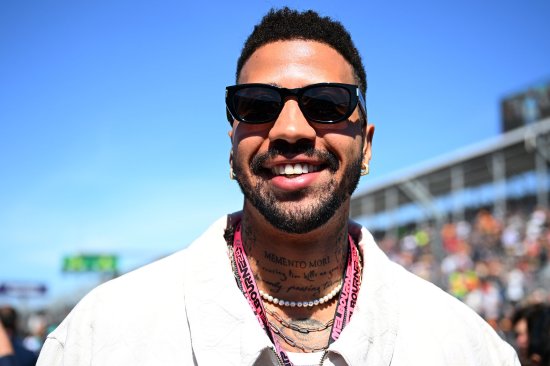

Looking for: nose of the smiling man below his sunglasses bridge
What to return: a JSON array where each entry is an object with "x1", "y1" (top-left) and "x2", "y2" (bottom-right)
[{"x1": 269, "y1": 99, "x2": 317, "y2": 144}]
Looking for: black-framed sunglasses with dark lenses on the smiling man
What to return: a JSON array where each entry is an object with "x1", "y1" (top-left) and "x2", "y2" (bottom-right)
[{"x1": 225, "y1": 83, "x2": 367, "y2": 124}]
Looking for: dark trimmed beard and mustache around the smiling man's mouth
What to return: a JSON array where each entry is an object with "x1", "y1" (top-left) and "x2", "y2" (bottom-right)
[{"x1": 233, "y1": 145, "x2": 362, "y2": 234}]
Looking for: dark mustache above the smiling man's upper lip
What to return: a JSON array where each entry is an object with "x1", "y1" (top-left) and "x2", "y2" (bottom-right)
[{"x1": 250, "y1": 143, "x2": 340, "y2": 174}]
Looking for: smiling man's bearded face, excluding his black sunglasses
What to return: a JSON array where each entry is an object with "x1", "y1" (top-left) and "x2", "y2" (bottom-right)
[{"x1": 230, "y1": 40, "x2": 374, "y2": 233}]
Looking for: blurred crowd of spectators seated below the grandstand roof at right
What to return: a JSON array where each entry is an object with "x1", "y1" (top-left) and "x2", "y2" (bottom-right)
[{"x1": 378, "y1": 207, "x2": 550, "y2": 365}]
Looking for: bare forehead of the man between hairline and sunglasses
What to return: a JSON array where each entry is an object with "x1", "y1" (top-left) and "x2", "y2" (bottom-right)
[{"x1": 242, "y1": 40, "x2": 356, "y2": 88}]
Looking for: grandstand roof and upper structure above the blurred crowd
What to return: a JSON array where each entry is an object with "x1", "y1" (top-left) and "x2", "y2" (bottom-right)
[{"x1": 351, "y1": 118, "x2": 550, "y2": 231}]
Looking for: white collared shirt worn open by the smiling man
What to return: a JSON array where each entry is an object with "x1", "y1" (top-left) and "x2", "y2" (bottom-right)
[{"x1": 37, "y1": 217, "x2": 519, "y2": 366}]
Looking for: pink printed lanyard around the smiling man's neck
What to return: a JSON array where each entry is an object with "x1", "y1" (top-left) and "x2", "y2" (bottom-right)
[{"x1": 233, "y1": 223, "x2": 361, "y2": 366}]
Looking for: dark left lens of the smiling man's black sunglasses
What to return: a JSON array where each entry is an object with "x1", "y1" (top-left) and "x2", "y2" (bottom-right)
[{"x1": 233, "y1": 86, "x2": 282, "y2": 123}]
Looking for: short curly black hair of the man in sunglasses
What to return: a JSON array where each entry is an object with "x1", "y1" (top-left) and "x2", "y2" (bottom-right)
[{"x1": 236, "y1": 7, "x2": 367, "y2": 94}]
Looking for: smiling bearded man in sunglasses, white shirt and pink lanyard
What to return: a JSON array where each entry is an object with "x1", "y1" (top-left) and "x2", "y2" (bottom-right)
[{"x1": 39, "y1": 8, "x2": 518, "y2": 366}]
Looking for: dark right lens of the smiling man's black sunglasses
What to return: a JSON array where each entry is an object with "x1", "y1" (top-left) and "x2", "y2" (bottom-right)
[{"x1": 301, "y1": 86, "x2": 351, "y2": 122}]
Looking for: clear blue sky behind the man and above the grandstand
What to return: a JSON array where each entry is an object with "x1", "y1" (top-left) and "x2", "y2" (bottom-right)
[{"x1": 0, "y1": 0, "x2": 550, "y2": 308}]
